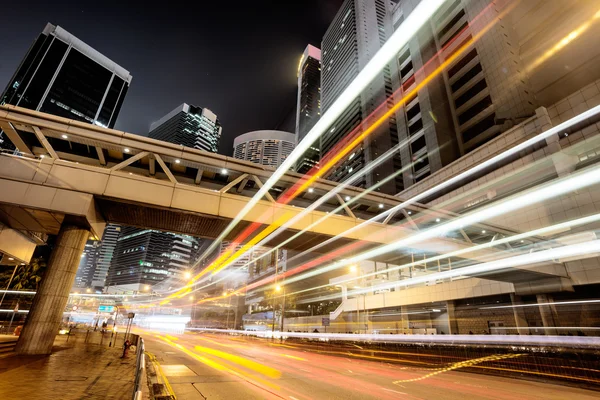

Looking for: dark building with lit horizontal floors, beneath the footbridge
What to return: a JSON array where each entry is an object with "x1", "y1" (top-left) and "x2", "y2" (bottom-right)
[{"x1": 106, "y1": 227, "x2": 201, "y2": 293}]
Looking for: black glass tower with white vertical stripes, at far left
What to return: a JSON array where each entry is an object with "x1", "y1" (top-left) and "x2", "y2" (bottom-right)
[{"x1": 0, "y1": 24, "x2": 132, "y2": 148}]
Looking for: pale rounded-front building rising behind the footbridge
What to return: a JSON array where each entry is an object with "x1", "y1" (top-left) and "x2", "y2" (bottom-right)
[{"x1": 233, "y1": 130, "x2": 296, "y2": 167}]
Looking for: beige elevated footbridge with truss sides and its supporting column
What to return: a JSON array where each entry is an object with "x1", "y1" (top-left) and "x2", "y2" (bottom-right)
[{"x1": 0, "y1": 106, "x2": 563, "y2": 353}]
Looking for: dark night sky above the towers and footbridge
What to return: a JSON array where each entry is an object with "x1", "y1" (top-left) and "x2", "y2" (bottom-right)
[{"x1": 0, "y1": 0, "x2": 342, "y2": 155}]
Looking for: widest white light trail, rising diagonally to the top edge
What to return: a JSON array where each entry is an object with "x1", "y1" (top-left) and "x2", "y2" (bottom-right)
[{"x1": 191, "y1": 0, "x2": 445, "y2": 266}]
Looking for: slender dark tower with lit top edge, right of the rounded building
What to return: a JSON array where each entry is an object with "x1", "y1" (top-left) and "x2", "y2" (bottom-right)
[{"x1": 296, "y1": 45, "x2": 321, "y2": 173}]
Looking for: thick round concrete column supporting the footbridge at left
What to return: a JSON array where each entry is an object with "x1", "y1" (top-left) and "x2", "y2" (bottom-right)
[{"x1": 15, "y1": 221, "x2": 90, "y2": 354}]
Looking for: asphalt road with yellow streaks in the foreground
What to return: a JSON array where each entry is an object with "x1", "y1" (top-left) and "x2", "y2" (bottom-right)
[{"x1": 142, "y1": 332, "x2": 600, "y2": 400}]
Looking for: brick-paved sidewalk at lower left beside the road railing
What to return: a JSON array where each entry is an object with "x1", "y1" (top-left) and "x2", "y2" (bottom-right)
[{"x1": 0, "y1": 333, "x2": 135, "y2": 400}]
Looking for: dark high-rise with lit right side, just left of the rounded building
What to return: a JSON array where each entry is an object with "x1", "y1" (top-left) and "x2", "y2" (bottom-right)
[{"x1": 148, "y1": 103, "x2": 221, "y2": 153}]
